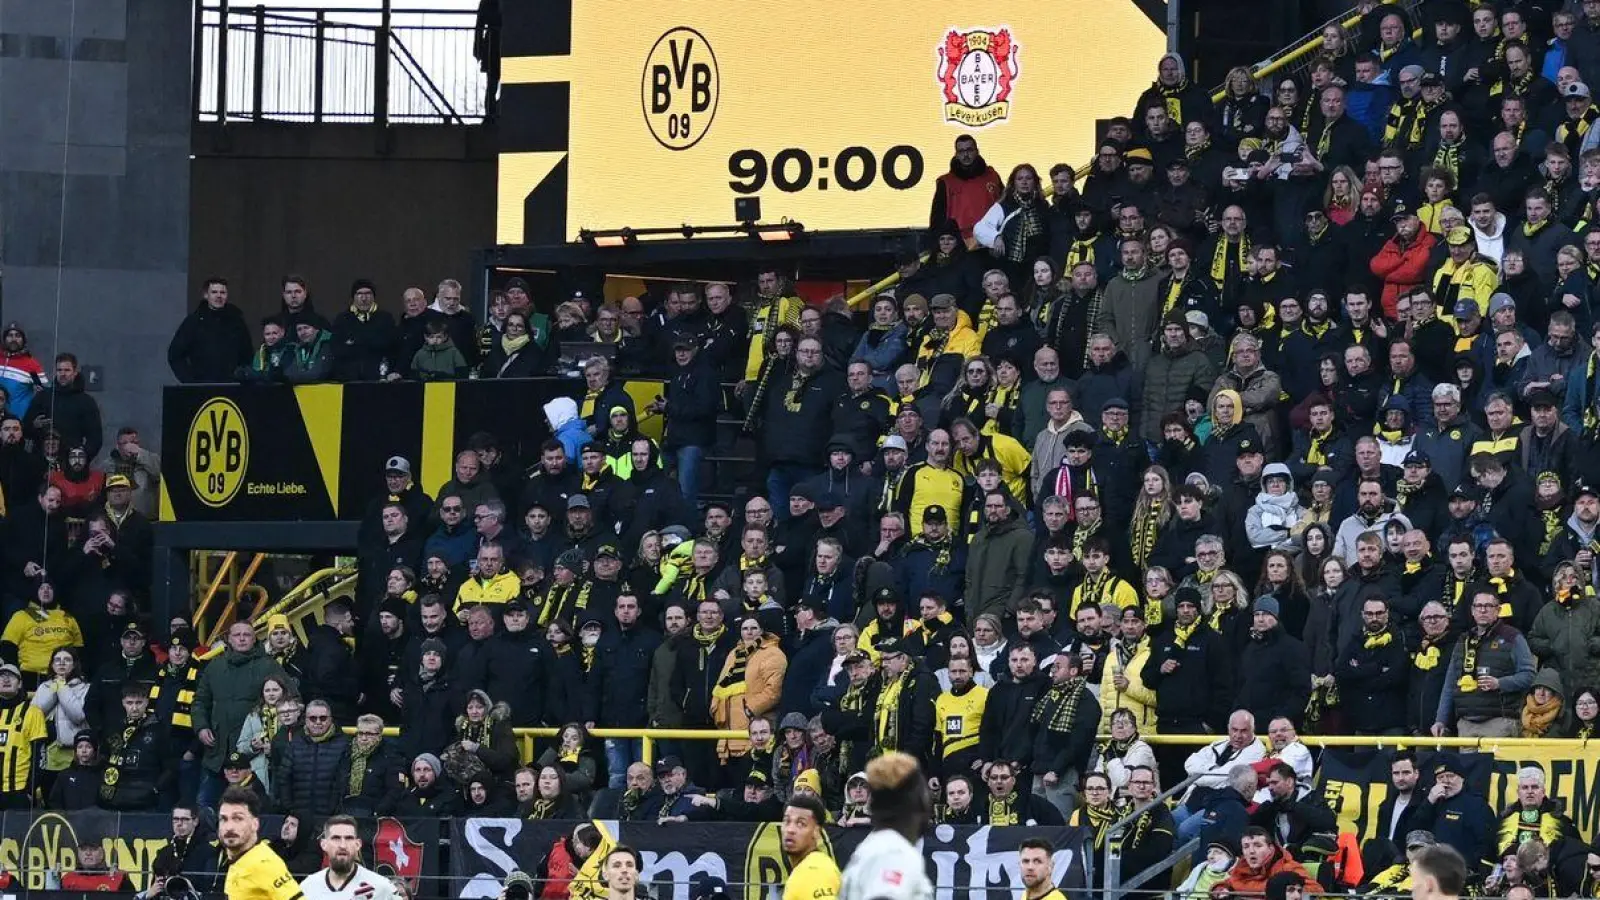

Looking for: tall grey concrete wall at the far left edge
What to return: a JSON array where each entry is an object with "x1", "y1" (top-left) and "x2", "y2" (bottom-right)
[{"x1": 0, "y1": 0, "x2": 194, "y2": 447}]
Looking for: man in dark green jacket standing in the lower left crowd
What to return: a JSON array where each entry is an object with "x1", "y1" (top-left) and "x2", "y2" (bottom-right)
[{"x1": 194, "y1": 621, "x2": 286, "y2": 807}]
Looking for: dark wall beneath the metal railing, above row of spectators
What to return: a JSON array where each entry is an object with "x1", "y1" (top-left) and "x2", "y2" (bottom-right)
[{"x1": 189, "y1": 123, "x2": 496, "y2": 331}]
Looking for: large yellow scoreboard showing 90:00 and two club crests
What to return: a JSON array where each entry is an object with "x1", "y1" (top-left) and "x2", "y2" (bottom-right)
[{"x1": 498, "y1": 0, "x2": 1165, "y2": 243}]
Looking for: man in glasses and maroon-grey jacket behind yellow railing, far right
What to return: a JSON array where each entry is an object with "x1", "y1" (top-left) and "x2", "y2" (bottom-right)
[{"x1": 1432, "y1": 586, "x2": 1534, "y2": 733}]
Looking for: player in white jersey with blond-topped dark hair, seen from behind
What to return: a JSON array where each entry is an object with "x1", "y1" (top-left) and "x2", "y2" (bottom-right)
[{"x1": 838, "y1": 751, "x2": 933, "y2": 900}]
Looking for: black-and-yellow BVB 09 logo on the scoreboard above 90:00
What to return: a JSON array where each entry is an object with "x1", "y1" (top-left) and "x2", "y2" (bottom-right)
[{"x1": 640, "y1": 26, "x2": 722, "y2": 151}]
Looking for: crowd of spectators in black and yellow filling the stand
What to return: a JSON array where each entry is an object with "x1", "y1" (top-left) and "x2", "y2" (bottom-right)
[{"x1": 15, "y1": 0, "x2": 1600, "y2": 897}]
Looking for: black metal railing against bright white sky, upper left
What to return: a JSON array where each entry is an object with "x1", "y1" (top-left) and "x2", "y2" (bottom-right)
[{"x1": 194, "y1": 0, "x2": 486, "y2": 125}]
